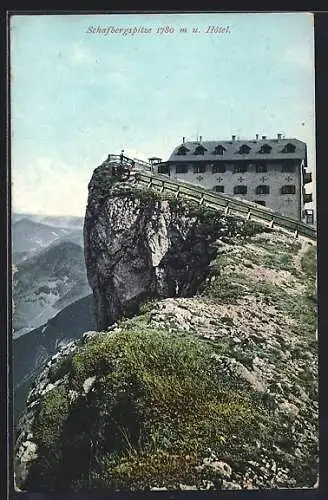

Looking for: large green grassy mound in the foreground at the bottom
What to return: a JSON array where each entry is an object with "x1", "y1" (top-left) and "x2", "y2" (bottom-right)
[{"x1": 29, "y1": 328, "x2": 290, "y2": 490}]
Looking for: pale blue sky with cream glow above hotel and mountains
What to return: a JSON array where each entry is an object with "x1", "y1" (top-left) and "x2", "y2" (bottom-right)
[{"x1": 10, "y1": 13, "x2": 315, "y2": 216}]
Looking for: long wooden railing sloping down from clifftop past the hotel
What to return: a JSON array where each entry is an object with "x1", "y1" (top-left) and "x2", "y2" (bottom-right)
[{"x1": 106, "y1": 155, "x2": 317, "y2": 240}]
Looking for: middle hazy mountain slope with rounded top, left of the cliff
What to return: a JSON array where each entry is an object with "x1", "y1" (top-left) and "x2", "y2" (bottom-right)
[{"x1": 13, "y1": 240, "x2": 90, "y2": 337}]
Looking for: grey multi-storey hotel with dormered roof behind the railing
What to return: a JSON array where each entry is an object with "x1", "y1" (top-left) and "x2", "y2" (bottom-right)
[{"x1": 154, "y1": 134, "x2": 313, "y2": 224}]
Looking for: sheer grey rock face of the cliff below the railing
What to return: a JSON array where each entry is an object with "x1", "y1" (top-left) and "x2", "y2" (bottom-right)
[{"x1": 84, "y1": 163, "x2": 258, "y2": 329}]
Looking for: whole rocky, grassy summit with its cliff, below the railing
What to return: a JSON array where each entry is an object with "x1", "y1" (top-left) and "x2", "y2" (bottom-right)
[{"x1": 15, "y1": 162, "x2": 318, "y2": 491}]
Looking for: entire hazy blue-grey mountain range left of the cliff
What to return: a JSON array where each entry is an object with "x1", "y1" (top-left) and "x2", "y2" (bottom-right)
[{"x1": 12, "y1": 214, "x2": 95, "y2": 416}]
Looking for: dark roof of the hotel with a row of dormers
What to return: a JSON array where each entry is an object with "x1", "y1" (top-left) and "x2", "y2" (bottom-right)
[{"x1": 168, "y1": 139, "x2": 306, "y2": 162}]
